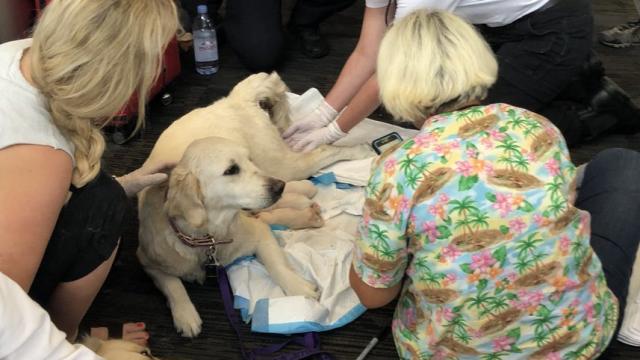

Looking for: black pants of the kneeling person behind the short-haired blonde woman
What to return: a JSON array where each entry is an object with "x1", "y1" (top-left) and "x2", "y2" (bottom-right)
[{"x1": 480, "y1": 0, "x2": 593, "y2": 145}]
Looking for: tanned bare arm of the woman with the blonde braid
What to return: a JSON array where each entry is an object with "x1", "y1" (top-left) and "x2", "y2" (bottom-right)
[{"x1": 0, "y1": 145, "x2": 73, "y2": 292}]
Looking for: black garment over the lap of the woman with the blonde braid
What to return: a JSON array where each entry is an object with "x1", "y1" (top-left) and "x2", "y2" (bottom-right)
[{"x1": 29, "y1": 172, "x2": 128, "y2": 306}]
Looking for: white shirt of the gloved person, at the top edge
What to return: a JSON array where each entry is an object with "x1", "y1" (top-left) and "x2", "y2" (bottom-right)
[{"x1": 366, "y1": 0, "x2": 550, "y2": 27}]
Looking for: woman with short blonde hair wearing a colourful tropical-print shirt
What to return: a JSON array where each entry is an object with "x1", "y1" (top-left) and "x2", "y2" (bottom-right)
[{"x1": 350, "y1": 10, "x2": 640, "y2": 359}]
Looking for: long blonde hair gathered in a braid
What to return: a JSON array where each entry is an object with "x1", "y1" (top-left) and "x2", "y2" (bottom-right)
[{"x1": 30, "y1": 0, "x2": 178, "y2": 187}]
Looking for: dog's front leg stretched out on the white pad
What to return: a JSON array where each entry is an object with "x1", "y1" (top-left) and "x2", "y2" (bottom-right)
[{"x1": 234, "y1": 215, "x2": 319, "y2": 299}]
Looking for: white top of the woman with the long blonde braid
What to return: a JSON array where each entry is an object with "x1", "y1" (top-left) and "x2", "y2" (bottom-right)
[{"x1": 0, "y1": 39, "x2": 73, "y2": 159}]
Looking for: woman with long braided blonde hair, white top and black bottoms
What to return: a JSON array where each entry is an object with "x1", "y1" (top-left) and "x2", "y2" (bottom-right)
[{"x1": 0, "y1": 0, "x2": 177, "y2": 354}]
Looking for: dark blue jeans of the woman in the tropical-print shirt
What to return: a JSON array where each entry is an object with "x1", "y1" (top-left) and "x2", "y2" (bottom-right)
[{"x1": 576, "y1": 149, "x2": 640, "y2": 320}]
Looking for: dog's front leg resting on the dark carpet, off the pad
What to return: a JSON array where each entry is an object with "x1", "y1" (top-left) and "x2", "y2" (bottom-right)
[{"x1": 144, "y1": 267, "x2": 202, "y2": 337}]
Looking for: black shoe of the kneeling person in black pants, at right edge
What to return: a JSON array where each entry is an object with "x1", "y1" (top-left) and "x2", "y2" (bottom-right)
[{"x1": 590, "y1": 76, "x2": 640, "y2": 134}]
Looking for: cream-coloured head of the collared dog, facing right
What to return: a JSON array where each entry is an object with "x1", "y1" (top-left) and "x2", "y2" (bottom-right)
[{"x1": 165, "y1": 137, "x2": 285, "y2": 228}]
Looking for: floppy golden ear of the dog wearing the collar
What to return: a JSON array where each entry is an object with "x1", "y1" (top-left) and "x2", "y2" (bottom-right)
[{"x1": 165, "y1": 167, "x2": 207, "y2": 228}]
